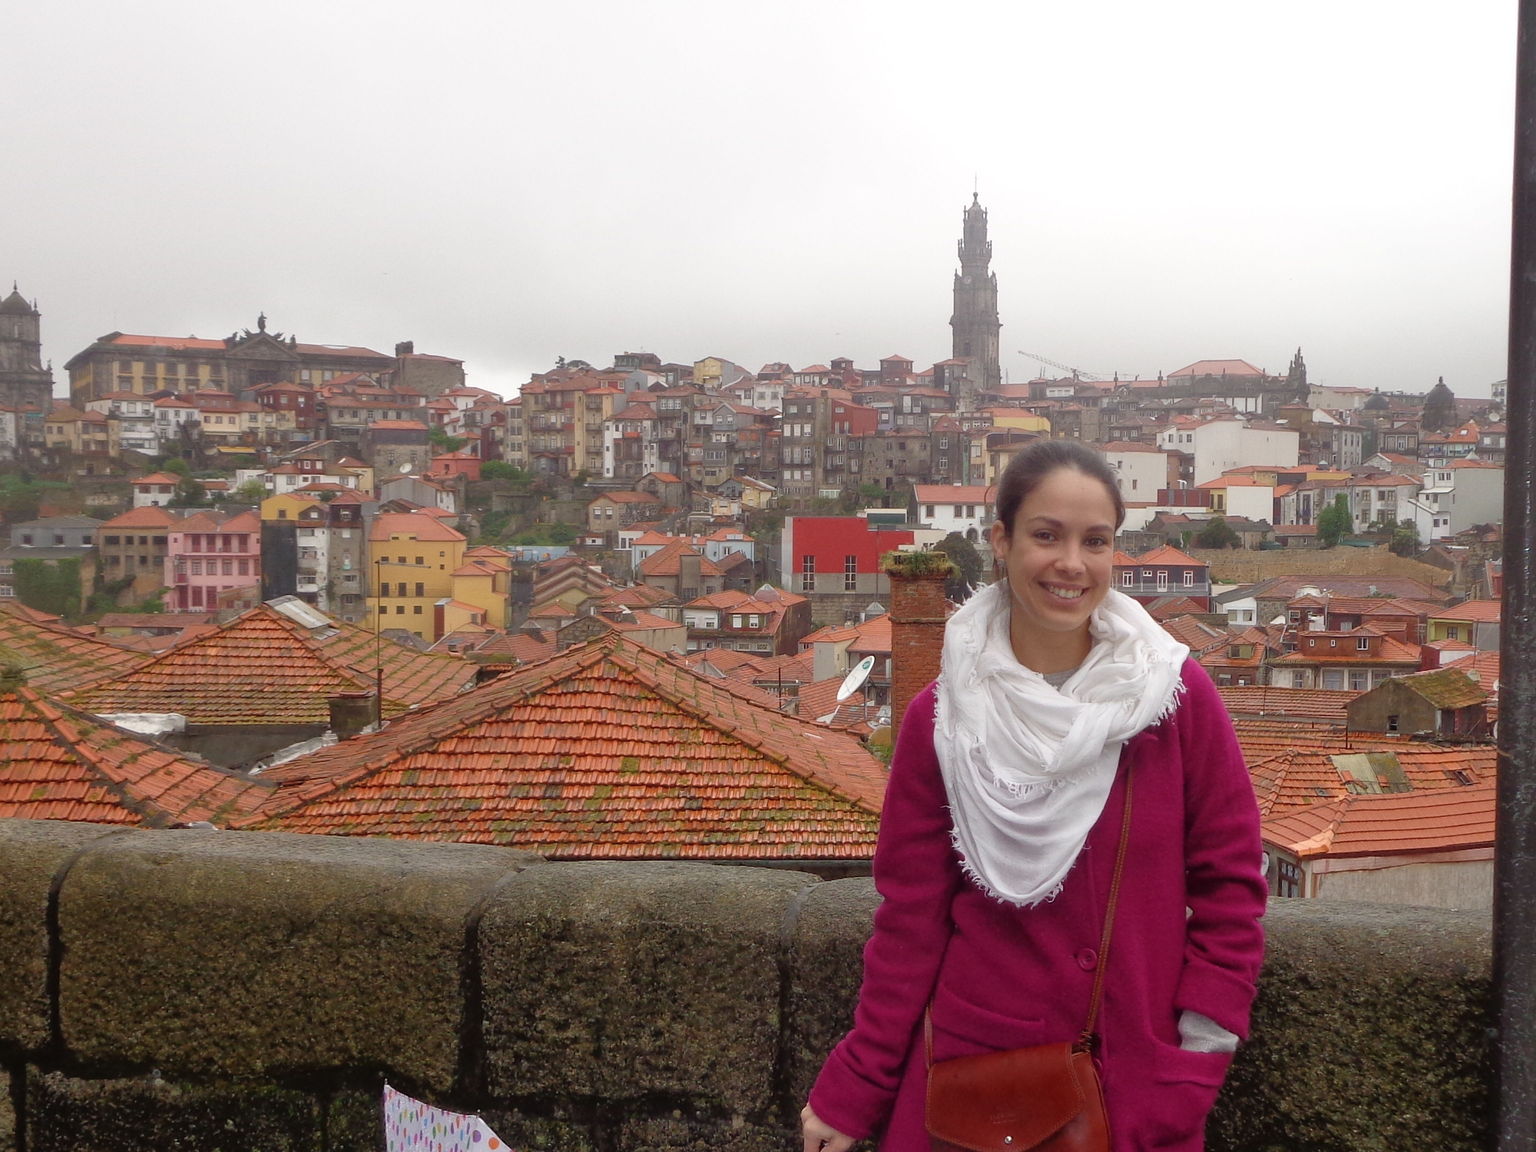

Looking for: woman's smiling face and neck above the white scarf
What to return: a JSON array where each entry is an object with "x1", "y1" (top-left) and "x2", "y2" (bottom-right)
[{"x1": 992, "y1": 467, "x2": 1115, "y2": 673}]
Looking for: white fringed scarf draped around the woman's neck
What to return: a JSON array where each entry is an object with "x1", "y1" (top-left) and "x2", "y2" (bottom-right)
[{"x1": 934, "y1": 581, "x2": 1189, "y2": 906}]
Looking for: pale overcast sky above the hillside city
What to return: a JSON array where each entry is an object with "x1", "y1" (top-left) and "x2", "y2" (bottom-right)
[{"x1": 0, "y1": 0, "x2": 1514, "y2": 396}]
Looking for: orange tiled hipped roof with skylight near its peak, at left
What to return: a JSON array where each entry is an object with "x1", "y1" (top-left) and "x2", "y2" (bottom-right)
[{"x1": 69, "y1": 605, "x2": 475, "y2": 725}]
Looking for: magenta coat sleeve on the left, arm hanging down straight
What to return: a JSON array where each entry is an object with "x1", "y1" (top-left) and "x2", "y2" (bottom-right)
[{"x1": 811, "y1": 685, "x2": 962, "y2": 1138}]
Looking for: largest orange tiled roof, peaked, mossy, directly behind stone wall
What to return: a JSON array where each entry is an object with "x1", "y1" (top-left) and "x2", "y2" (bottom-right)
[{"x1": 247, "y1": 633, "x2": 885, "y2": 860}]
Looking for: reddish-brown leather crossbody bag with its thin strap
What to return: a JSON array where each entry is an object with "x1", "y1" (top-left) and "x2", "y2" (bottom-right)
[{"x1": 923, "y1": 776, "x2": 1132, "y2": 1152}]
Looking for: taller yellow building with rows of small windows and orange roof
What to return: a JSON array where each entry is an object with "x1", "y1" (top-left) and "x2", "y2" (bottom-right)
[{"x1": 367, "y1": 511, "x2": 467, "y2": 644}]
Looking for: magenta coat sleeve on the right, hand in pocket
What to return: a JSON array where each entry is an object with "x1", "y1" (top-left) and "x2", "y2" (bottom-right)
[{"x1": 1174, "y1": 660, "x2": 1267, "y2": 1038}]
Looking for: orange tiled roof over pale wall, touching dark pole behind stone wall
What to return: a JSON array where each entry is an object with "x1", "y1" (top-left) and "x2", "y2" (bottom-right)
[{"x1": 1263, "y1": 783, "x2": 1496, "y2": 859}]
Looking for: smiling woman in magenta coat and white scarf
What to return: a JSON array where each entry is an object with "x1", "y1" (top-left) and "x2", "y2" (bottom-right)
[{"x1": 802, "y1": 441, "x2": 1264, "y2": 1152}]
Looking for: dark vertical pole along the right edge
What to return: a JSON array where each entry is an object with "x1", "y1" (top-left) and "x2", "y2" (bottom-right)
[{"x1": 1493, "y1": 0, "x2": 1536, "y2": 1152}]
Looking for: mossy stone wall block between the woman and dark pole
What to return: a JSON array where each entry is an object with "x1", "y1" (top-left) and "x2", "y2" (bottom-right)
[{"x1": 1207, "y1": 900, "x2": 1493, "y2": 1152}]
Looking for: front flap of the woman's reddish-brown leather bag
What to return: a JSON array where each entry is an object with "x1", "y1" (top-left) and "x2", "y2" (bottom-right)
[{"x1": 928, "y1": 1043, "x2": 1092, "y2": 1152}]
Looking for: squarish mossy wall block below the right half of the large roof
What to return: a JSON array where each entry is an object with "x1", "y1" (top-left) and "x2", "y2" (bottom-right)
[{"x1": 481, "y1": 863, "x2": 819, "y2": 1114}]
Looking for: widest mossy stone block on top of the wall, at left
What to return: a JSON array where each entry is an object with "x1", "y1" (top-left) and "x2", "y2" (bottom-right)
[{"x1": 60, "y1": 829, "x2": 538, "y2": 1092}]
